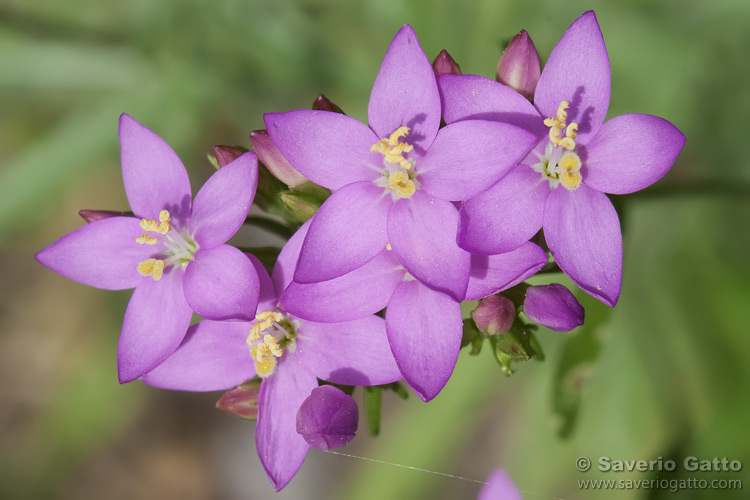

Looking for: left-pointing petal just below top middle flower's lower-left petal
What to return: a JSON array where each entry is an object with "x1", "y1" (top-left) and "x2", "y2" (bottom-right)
[{"x1": 279, "y1": 250, "x2": 406, "y2": 323}]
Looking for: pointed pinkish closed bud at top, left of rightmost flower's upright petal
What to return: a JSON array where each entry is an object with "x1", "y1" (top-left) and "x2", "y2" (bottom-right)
[{"x1": 495, "y1": 30, "x2": 542, "y2": 101}]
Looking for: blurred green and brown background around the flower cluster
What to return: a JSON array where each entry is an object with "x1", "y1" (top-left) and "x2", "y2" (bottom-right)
[{"x1": 0, "y1": 0, "x2": 750, "y2": 500}]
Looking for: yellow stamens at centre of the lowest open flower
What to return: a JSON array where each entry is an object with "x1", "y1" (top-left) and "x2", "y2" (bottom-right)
[{"x1": 247, "y1": 311, "x2": 297, "y2": 378}]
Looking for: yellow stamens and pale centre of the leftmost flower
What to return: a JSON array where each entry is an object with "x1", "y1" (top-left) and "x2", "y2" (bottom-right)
[{"x1": 135, "y1": 210, "x2": 199, "y2": 281}]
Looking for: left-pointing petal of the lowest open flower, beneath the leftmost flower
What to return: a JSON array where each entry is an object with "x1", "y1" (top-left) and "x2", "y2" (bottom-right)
[{"x1": 141, "y1": 320, "x2": 255, "y2": 391}]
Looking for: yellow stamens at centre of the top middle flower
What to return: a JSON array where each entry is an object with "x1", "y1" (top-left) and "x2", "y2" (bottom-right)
[{"x1": 370, "y1": 127, "x2": 419, "y2": 201}]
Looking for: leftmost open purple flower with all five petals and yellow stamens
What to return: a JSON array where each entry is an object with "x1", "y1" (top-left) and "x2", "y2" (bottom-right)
[{"x1": 36, "y1": 114, "x2": 260, "y2": 383}]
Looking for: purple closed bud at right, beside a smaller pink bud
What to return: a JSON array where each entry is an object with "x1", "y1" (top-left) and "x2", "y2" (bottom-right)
[{"x1": 523, "y1": 283, "x2": 585, "y2": 332}]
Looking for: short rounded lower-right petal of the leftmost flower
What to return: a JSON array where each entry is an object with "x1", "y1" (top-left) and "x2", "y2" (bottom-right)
[{"x1": 185, "y1": 245, "x2": 260, "y2": 321}]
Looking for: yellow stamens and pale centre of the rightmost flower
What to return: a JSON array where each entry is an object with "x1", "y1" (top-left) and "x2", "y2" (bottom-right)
[{"x1": 531, "y1": 101, "x2": 583, "y2": 191}]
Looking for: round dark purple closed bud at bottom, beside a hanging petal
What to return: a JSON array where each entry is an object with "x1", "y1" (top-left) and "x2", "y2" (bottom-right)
[{"x1": 297, "y1": 385, "x2": 359, "y2": 450}]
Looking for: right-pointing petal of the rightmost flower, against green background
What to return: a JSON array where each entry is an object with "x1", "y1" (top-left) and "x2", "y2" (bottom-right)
[{"x1": 583, "y1": 114, "x2": 685, "y2": 194}]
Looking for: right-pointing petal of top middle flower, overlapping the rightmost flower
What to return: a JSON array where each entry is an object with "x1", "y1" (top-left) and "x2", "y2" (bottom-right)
[{"x1": 418, "y1": 120, "x2": 537, "y2": 201}]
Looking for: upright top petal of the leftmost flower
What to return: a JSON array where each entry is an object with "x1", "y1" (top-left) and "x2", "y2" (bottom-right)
[{"x1": 120, "y1": 114, "x2": 192, "y2": 225}]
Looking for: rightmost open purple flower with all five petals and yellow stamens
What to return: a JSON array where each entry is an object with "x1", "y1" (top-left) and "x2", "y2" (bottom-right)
[{"x1": 439, "y1": 12, "x2": 685, "y2": 306}]
